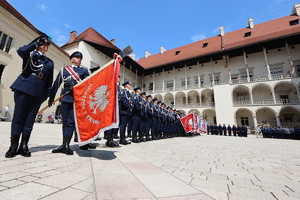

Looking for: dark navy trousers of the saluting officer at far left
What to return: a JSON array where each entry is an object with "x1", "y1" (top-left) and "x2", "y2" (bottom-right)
[{"x1": 11, "y1": 90, "x2": 44, "y2": 135}]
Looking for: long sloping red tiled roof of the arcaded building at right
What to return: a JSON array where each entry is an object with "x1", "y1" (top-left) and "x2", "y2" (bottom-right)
[{"x1": 138, "y1": 15, "x2": 300, "y2": 69}]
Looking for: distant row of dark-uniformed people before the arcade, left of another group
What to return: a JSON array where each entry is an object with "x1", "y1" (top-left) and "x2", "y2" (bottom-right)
[{"x1": 207, "y1": 124, "x2": 248, "y2": 137}]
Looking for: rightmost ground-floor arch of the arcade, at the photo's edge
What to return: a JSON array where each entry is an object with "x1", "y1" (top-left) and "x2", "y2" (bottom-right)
[{"x1": 278, "y1": 106, "x2": 300, "y2": 127}]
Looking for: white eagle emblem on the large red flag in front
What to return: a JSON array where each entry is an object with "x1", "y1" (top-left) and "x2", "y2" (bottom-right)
[{"x1": 89, "y1": 85, "x2": 110, "y2": 114}]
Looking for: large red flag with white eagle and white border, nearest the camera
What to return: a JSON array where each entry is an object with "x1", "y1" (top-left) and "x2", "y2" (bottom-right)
[{"x1": 73, "y1": 55, "x2": 122, "y2": 146}]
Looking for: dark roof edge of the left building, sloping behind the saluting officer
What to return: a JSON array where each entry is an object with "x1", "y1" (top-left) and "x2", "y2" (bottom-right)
[{"x1": 0, "y1": 0, "x2": 69, "y2": 57}]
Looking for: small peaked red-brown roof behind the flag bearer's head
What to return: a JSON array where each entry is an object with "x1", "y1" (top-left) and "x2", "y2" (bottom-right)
[{"x1": 62, "y1": 27, "x2": 120, "y2": 51}]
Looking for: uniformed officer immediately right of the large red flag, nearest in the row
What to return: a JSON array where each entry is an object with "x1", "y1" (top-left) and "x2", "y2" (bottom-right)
[{"x1": 119, "y1": 81, "x2": 132, "y2": 145}]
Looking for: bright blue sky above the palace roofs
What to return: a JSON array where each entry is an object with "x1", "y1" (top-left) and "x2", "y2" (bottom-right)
[{"x1": 8, "y1": 0, "x2": 300, "y2": 58}]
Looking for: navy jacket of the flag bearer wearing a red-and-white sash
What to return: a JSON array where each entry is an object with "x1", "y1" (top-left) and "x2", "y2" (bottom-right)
[{"x1": 50, "y1": 66, "x2": 90, "y2": 103}]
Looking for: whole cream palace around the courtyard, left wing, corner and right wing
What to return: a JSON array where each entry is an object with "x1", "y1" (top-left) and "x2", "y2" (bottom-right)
[{"x1": 0, "y1": 0, "x2": 300, "y2": 130}]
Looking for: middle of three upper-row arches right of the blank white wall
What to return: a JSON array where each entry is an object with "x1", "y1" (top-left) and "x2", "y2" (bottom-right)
[{"x1": 252, "y1": 83, "x2": 273, "y2": 104}]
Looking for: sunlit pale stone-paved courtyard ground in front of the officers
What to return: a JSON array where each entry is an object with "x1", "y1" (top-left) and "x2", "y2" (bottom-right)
[{"x1": 0, "y1": 122, "x2": 300, "y2": 200}]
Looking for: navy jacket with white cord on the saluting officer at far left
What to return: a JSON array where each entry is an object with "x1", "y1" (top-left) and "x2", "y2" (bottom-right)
[{"x1": 10, "y1": 43, "x2": 54, "y2": 100}]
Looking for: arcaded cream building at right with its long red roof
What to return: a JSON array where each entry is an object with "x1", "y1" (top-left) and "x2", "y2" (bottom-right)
[{"x1": 138, "y1": 4, "x2": 300, "y2": 128}]
